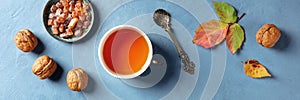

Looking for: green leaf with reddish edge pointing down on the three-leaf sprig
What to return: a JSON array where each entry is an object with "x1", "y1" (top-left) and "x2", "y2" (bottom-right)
[{"x1": 226, "y1": 23, "x2": 245, "y2": 54}]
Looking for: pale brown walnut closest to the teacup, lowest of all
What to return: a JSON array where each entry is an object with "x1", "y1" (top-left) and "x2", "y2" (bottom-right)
[{"x1": 66, "y1": 68, "x2": 88, "y2": 91}]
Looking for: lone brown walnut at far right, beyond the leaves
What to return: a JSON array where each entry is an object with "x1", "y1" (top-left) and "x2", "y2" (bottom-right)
[{"x1": 256, "y1": 24, "x2": 280, "y2": 48}]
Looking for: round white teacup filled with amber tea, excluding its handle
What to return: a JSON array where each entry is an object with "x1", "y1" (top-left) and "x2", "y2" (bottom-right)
[{"x1": 98, "y1": 25, "x2": 153, "y2": 79}]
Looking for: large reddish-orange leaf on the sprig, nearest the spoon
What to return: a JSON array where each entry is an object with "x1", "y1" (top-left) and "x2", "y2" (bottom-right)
[{"x1": 193, "y1": 20, "x2": 229, "y2": 48}]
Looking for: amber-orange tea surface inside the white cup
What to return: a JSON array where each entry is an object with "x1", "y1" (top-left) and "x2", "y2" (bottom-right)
[{"x1": 102, "y1": 28, "x2": 149, "y2": 75}]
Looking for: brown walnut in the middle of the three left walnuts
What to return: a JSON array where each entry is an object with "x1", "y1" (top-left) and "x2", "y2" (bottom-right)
[{"x1": 32, "y1": 55, "x2": 57, "y2": 79}]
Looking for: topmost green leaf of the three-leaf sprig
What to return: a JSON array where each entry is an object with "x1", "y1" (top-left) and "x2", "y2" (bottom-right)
[{"x1": 214, "y1": 1, "x2": 238, "y2": 23}]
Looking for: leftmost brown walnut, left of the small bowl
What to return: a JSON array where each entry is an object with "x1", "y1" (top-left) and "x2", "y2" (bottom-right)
[{"x1": 14, "y1": 29, "x2": 38, "y2": 52}]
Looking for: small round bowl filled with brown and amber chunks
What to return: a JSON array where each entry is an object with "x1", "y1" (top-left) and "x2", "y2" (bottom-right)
[{"x1": 43, "y1": 0, "x2": 94, "y2": 42}]
